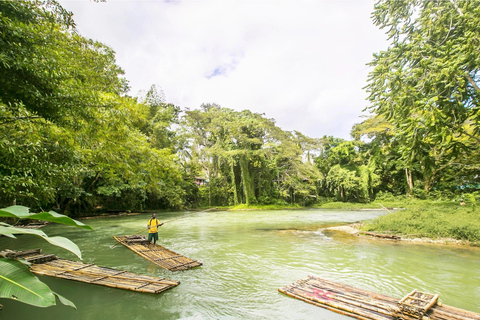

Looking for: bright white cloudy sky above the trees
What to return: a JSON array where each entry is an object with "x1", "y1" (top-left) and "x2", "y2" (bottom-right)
[{"x1": 59, "y1": 0, "x2": 388, "y2": 139}]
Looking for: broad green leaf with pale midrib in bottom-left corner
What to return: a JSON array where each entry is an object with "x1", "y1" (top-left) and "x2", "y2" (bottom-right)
[{"x1": 0, "y1": 258, "x2": 55, "y2": 307}]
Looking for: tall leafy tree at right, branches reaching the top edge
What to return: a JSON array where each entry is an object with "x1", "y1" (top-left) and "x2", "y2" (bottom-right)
[{"x1": 366, "y1": 0, "x2": 480, "y2": 192}]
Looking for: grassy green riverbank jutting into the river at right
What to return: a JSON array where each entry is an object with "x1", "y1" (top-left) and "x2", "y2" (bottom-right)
[{"x1": 312, "y1": 197, "x2": 480, "y2": 246}]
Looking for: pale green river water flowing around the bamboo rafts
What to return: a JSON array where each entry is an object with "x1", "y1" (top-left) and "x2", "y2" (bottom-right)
[{"x1": 0, "y1": 209, "x2": 480, "y2": 320}]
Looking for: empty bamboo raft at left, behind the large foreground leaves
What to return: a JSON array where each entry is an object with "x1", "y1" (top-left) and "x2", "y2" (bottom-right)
[{"x1": 3, "y1": 249, "x2": 180, "y2": 293}]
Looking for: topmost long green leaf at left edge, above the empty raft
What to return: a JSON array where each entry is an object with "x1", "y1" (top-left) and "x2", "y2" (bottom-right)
[{"x1": 0, "y1": 206, "x2": 93, "y2": 230}]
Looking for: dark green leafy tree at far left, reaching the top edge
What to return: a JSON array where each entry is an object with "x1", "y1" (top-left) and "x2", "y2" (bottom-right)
[{"x1": 0, "y1": 0, "x2": 126, "y2": 208}]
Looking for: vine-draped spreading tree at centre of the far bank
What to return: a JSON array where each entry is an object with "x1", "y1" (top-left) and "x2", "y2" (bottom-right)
[{"x1": 185, "y1": 105, "x2": 318, "y2": 205}]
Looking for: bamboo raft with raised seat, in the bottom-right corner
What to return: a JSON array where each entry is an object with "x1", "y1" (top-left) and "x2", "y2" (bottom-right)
[{"x1": 278, "y1": 276, "x2": 480, "y2": 320}]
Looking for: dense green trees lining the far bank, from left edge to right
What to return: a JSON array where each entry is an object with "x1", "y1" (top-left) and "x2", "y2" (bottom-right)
[{"x1": 0, "y1": 0, "x2": 480, "y2": 216}]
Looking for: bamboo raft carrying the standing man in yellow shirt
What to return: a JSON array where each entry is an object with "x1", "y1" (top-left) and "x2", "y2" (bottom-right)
[{"x1": 113, "y1": 235, "x2": 202, "y2": 271}]
